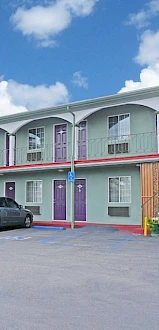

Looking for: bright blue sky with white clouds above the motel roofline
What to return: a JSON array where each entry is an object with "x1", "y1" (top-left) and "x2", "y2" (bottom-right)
[{"x1": 0, "y1": 0, "x2": 159, "y2": 116}]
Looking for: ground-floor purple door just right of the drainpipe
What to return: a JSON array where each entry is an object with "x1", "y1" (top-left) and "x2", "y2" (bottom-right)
[{"x1": 75, "y1": 179, "x2": 86, "y2": 221}]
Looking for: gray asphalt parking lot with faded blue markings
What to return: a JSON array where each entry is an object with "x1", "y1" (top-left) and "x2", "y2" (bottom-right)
[{"x1": 0, "y1": 227, "x2": 159, "y2": 330}]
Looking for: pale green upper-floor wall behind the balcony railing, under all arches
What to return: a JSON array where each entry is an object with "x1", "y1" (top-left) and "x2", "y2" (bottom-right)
[{"x1": 0, "y1": 105, "x2": 155, "y2": 165}]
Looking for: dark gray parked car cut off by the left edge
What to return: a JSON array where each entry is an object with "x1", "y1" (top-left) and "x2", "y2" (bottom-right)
[{"x1": 0, "y1": 197, "x2": 33, "y2": 228}]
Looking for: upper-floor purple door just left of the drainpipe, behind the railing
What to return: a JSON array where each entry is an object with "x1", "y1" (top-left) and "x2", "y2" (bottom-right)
[{"x1": 55, "y1": 124, "x2": 67, "y2": 162}]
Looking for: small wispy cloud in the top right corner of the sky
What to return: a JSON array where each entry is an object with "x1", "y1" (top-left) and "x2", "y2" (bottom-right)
[{"x1": 126, "y1": 0, "x2": 159, "y2": 29}]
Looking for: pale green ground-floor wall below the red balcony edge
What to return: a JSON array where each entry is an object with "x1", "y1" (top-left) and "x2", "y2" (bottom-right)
[{"x1": 0, "y1": 165, "x2": 141, "y2": 225}]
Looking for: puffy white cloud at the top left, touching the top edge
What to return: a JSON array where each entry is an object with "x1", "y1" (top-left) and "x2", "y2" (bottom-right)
[{"x1": 10, "y1": 0, "x2": 99, "y2": 47}]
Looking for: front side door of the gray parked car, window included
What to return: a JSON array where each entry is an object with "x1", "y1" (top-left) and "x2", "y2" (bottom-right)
[{"x1": 6, "y1": 198, "x2": 22, "y2": 226}]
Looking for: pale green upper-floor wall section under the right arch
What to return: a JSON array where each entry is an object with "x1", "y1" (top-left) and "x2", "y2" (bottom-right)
[{"x1": 87, "y1": 105, "x2": 157, "y2": 159}]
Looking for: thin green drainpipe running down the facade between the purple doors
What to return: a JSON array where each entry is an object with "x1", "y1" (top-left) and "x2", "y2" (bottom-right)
[{"x1": 67, "y1": 106, "x2": 76, "y2": 229}]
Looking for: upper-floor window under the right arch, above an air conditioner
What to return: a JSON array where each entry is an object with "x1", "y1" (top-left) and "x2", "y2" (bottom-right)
[{"x1": 108, "y1": 114, "x2": 130, "y2": 139}]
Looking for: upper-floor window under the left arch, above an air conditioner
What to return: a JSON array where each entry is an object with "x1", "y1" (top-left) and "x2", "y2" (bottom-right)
[{"x1": 29, "y1": 127, "x2": 44, "y2": 150}]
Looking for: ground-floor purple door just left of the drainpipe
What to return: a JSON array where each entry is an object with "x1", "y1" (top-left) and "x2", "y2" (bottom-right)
[{"x1": 54, "y1": 180, "x2": 66, "y2": 220}]
